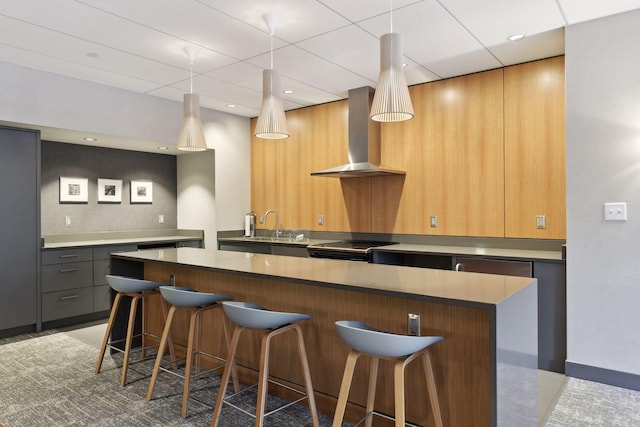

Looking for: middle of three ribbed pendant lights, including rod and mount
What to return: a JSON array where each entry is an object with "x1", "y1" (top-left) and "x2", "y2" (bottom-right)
[{"x1": 253, "y1": 14, "x2": 289, "y2": 139}]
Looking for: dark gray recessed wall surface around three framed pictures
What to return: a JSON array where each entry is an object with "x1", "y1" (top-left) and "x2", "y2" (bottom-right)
[{"x1": 41, "y1": 141, "x2": 177, "y2": 235}]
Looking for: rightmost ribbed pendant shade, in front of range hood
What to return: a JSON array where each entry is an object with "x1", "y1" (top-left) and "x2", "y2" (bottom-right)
[{"x1": 369, "y1": 33, "x2": 414, "y2": 122}]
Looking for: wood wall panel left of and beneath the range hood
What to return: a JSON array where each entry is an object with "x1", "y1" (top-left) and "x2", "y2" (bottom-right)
[{"x1": 251, "y1": 100, "x2": 371, "y2": 232}]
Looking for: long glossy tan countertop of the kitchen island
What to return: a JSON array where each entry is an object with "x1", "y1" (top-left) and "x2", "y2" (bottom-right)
[{"x1": 112, "y1": 248, "x2": 536, "y2": 307}]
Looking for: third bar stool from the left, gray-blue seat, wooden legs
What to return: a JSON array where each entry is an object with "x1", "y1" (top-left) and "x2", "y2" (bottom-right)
[{"x1": 211, "y1": 301, "x2": 319, "y2": 427}]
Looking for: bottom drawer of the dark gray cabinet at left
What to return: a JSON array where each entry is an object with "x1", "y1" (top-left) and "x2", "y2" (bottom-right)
[{"x1": 42, "y1": 287, "x2": 93, "y2": 322}]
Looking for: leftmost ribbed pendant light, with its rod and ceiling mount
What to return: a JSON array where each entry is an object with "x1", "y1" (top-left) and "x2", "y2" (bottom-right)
[{"x1": 178, "y1": 46, "x2": 207, "y2": 151}]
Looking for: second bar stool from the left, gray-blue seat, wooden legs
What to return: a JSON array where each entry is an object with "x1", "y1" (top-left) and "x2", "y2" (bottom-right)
[{"x1": 147, "y1": 286, "x2": 240, "y2": 418}]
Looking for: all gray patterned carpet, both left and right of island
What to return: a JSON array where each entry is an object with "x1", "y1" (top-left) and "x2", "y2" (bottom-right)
[{"x1": 0, "y1": 331, "x2": 640, "y2": 427}]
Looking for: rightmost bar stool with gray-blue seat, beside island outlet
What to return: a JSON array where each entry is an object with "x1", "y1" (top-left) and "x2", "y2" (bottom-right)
[{"x1": 333, "y1": 320, "x2": 443, "y2": 427}]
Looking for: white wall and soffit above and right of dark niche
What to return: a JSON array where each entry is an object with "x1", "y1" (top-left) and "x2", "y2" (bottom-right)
[{"x1": 0, "y1": 62, "x2": 251, "y2": 247}]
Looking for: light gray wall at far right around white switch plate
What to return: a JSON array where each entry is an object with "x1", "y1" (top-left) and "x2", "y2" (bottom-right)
[{"x1": 565, "y1": 10, "x2": 640, "y2": 375}]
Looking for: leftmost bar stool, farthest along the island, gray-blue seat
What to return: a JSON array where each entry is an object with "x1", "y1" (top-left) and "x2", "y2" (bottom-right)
[{"x1": 96, "y1": 274, "x2": 175, "y2": 385}]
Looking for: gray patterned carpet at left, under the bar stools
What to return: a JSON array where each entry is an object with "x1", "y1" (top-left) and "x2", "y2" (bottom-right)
[{"x1": 0, "y1": 333, "x2": 331, "y2": 427}]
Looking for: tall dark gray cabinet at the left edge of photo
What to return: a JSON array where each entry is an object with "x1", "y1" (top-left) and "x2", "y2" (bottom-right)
[{"x1": 0, "y1": 127, "x2": 40, "y2": 335}]
